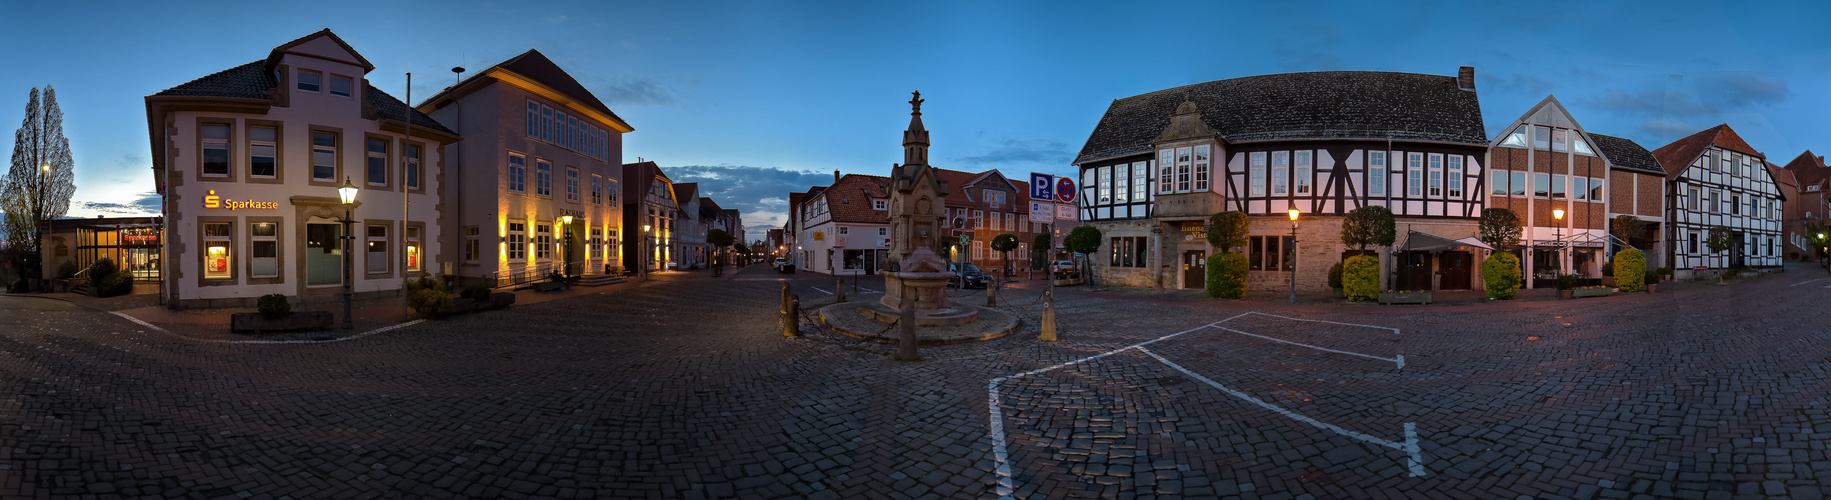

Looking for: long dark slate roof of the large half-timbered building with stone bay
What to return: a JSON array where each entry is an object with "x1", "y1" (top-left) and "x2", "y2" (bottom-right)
[{"x1": 1073, "y1": 71, "x2": 1487, "y2": 165}]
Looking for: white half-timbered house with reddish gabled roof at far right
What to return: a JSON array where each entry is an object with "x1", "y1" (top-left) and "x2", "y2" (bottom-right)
[{"x1": 1653, "y1": 125, "x2": 1785, "y2": 277}]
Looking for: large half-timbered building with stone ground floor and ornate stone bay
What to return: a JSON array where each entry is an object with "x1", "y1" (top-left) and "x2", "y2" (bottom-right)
[{"x1": 1075, "y1": 66, "x2": 1487, "y2": 291}]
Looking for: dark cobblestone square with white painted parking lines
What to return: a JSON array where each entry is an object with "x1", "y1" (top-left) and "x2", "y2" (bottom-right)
[{"x1": 0, "y1": 267, "x2": 1831, "y2": 498}]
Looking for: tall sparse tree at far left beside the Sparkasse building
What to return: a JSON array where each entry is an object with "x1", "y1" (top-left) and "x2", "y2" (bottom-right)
[{"x1": 0, "y1": 86, "x2": 77, "y2": 287}]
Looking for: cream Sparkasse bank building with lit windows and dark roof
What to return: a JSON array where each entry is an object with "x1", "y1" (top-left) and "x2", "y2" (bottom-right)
[{"x1": 146, "y1": 29, "x2": 460, "y2": 308}]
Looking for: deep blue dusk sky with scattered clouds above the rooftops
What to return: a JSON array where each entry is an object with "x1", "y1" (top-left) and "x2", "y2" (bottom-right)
[{"x1": 0, "y1": 0, "x2": 1831, "y2": 240}]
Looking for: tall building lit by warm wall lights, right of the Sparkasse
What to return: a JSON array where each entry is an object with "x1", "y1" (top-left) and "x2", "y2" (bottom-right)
[{"x1": 419, "y1": 49, "x2": 634, "y2": 286}]
